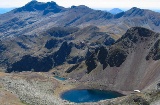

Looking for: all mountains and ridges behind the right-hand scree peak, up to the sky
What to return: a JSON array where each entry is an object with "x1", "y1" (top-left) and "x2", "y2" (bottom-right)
[{"x1": 0, "y1": 1, "x2": 160, "y2": 72}]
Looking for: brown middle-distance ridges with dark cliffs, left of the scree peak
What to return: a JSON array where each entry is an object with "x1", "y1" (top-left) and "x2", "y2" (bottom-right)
[{"x1": 0, "y1": 26, "x2": 114, "y2": 72}]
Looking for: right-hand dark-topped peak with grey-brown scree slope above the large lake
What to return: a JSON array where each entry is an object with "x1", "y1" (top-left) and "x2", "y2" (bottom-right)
[{"x1": 67, "y1": 27, "x2": 160, "y2": 91}]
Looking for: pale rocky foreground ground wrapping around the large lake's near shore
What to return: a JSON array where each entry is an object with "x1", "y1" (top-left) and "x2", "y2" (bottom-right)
[{"x1": 0, "y1": 72, "x2": 160, "y2": 105}]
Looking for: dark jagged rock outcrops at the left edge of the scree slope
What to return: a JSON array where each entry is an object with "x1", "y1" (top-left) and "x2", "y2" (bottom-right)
[{"x1": 86, "y1": 46, "x2": 127, "y2": 73}]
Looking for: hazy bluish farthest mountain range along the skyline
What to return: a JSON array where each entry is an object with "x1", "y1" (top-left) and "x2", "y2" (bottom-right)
[{"x1": 0, "y1": 1, "x2": 159, "y2": 37}]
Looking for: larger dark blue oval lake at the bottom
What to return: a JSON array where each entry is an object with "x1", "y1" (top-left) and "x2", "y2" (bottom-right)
[{"x1": 61, "y1": 89, "x2": 124, "y2": 103}]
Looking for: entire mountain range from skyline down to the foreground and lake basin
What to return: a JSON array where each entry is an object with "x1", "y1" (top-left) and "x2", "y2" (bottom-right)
[{"x1": 0, "y1": 1, "x2": 160, "y2": 93}]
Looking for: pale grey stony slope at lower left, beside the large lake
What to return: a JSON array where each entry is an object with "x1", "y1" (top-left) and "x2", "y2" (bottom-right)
[{"x1": 0, "y1": 73, "x2": 70, "y2": 105}]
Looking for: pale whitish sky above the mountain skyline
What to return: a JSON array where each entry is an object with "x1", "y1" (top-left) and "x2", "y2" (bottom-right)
[{"x1": 0, "y1": 0, "x2": 160, "y2": 10}]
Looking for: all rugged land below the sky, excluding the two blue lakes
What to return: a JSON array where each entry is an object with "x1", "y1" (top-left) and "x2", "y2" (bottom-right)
[{"x1": 0, "y1": 1, "x2": 160, "y2": 105}]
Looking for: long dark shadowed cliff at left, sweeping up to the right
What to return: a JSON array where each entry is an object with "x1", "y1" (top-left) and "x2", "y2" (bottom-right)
[{"x1": 6, "y1": 42, "x2": 72, "y2": 72}]
